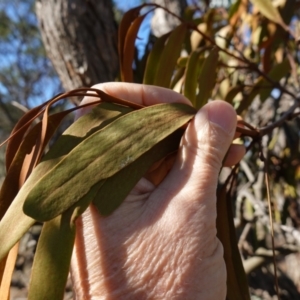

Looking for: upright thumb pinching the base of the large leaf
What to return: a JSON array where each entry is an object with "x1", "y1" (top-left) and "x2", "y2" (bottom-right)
[{"x1": 158, "y1": 101, "x2": 237, "y2": 201}]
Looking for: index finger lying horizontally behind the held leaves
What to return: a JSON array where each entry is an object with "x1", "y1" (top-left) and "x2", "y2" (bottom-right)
[{"x1": 76, "y1": 82, "x2": 191, "y2": 118}]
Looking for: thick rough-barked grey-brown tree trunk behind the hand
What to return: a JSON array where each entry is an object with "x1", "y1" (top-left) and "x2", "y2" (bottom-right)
[{"x1": 36, "y1": 0, "x2": 119, "y2": 90}]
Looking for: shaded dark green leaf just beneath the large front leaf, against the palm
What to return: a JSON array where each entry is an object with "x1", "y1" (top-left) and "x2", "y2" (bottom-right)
[{"x1": 93, "y1": 129, "x2": 184, "y2": 215}]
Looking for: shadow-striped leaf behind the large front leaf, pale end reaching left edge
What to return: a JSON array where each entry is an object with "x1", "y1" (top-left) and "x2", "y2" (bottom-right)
[{"x1": 0, "y1": 103, "x2": 132, "y2": 261}]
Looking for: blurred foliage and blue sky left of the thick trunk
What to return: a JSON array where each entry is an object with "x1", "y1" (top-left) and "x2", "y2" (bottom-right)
[{"x1": 0, "y1": 0, "x2": 61, "y2": 186}]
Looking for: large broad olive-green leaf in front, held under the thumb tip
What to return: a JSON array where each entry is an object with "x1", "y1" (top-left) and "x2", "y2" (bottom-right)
[{"x1": 24, "y1": 103, "x2": 195, "y2": 221}]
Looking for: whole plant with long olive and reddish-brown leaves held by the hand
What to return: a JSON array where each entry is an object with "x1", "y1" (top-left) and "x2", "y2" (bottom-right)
[{"x1": 0, "y1": 0, "x2": 299, "y2": 300}]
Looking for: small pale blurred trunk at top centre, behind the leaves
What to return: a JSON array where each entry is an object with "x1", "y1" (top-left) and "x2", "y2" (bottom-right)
[{"x1": 151, "y1": 0, "x2": 187, "y2": 37}]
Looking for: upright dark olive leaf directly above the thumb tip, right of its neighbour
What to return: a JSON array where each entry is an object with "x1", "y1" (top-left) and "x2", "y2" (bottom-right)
[{"x1": 196, "y1": 48, "x2": 219, "y2": 109}]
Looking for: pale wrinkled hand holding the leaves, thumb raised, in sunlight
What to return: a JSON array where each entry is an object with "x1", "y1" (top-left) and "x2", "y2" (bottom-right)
[{"x1": 71, "y1": 83, "x2": 245, "y2": 300}]
